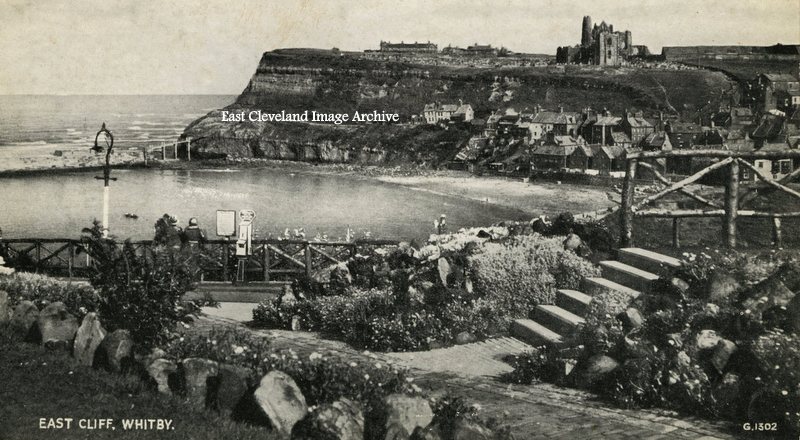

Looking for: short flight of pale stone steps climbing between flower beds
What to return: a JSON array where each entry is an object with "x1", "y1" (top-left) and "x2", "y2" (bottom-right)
[{"x1": 511, "y1": 248, "x2": 680, "y2": 346}]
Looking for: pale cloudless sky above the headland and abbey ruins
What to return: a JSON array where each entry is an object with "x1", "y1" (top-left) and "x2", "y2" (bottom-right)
[{"x1": 0, "y1": 0, "x2": 800, "y2": 94}]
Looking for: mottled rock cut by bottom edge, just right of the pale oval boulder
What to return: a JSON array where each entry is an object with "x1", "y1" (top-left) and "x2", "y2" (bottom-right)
[{"x1": 292, "y1": 398, "x2": 364, "y2": 440}]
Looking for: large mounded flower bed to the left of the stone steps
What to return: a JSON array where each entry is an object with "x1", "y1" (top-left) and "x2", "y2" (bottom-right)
[{"x1": 253, "y1": 227, "x2": 597, "y2": 351}]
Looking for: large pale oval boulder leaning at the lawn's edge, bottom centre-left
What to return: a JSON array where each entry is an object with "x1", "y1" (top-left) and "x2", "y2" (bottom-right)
[{"x1": 253, "y1": 371, "x2": 308, "y2": 437}]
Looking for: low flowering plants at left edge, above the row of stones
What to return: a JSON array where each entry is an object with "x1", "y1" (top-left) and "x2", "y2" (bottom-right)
[{"x1": 0, "y1": 272, "x2": 101, "y2": 320}]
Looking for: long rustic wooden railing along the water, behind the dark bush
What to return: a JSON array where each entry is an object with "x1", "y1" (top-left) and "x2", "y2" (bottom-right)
[{"x1": 0, "y1": 238, "x2": 398, "y2": 282}]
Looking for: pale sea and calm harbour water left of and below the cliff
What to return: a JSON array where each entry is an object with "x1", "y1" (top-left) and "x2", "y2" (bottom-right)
[{"x1": 0, "y1": 95, "x2": 526, "y2": 240}]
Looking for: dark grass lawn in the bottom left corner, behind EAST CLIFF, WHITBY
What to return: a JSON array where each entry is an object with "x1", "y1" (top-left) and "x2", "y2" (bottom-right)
[{"x1": 0, "y1": 335, "x2": 278, "y2": 440}]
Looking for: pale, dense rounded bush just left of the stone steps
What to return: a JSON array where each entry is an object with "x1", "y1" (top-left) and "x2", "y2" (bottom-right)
[{"x1": 469, "y1": 234, "x2": 598, "y2": 319}]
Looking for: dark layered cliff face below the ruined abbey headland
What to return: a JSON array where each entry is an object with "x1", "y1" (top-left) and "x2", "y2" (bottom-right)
[{"x1": 183, "y1": 49, "x2": 729, "y2": 165}]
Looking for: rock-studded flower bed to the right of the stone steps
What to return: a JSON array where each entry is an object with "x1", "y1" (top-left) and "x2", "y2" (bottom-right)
[{"x1": 508, "y1": 249, "x2": 800, "y2": 437}]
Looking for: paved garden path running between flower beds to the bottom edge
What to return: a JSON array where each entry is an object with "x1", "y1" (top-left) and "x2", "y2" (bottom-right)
[{"x1": 198, "y1": 304, "x2": 735, "y2": 440}]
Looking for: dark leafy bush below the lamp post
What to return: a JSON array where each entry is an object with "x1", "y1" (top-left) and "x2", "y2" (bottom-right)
[{"x1": 84, "y1": 223, "x2": 193, "y2": 350}]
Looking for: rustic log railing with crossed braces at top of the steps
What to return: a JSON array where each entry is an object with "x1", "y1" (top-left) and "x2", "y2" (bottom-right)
[{"x1": 620, "y1": 150, "x2": 800, "y2": 248}]
